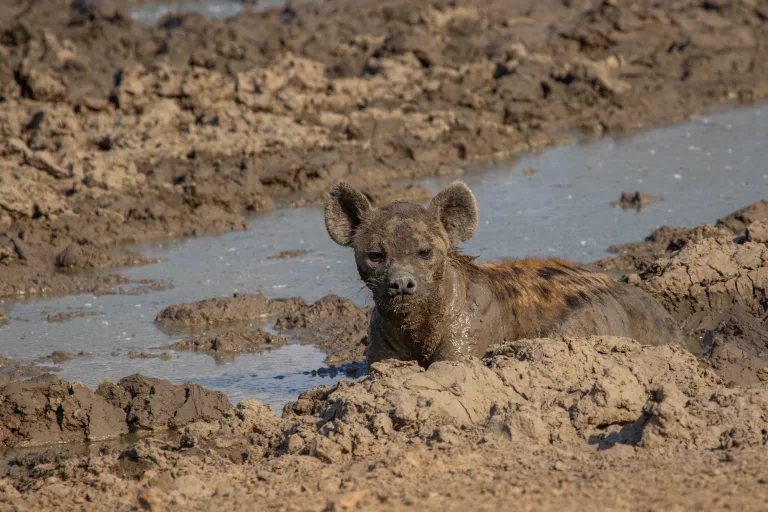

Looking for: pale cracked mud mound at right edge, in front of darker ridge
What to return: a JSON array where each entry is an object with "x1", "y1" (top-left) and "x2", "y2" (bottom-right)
[{"x1": 636, "y1": 234, "x2": 768, "y2": 385}]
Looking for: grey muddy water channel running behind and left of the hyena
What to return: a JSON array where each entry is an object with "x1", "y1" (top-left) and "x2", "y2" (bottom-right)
[{"x1": 0, "y1": 109, "x2": 768, "y2": 409}]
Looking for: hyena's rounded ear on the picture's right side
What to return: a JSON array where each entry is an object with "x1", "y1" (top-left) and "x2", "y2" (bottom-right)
[{"x1": 429, "y1": 181, "x2": 477, "y2": 244}]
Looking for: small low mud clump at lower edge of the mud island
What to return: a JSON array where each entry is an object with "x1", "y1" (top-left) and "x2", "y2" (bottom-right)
[{"x1": 172, "y1": 329, "x2": 290, "y2": 359}]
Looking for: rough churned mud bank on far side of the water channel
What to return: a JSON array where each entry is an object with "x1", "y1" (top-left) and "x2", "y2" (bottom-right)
[{"x1": 0, "y1": 0, "x2": 768, "y2": 297}]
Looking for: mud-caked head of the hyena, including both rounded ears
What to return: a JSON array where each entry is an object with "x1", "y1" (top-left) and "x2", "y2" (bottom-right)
[{"x1": 325, "y1": 182, "x2": 477, "y2": 312}]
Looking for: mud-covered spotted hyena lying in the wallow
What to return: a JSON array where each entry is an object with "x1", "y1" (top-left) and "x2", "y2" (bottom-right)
[{"x1": 325, "y1": 182, "x2": 682, "y2": 367}]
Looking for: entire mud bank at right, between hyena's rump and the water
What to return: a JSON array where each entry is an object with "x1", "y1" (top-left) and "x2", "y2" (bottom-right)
[{"x1": 592, "y1": 201, "x2": 768, "y2": 385}]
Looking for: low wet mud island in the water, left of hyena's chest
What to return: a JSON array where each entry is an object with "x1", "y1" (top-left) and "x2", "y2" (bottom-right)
[{"x1": 156, "y1": 294, "x2": 370, "y2": 365}]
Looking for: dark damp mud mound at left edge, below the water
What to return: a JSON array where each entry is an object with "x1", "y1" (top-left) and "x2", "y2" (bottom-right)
[{"x1": 0, "y1": 375, "x2": 231, "y2": 448}]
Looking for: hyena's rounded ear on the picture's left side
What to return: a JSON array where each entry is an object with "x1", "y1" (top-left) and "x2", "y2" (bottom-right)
[{"x1": 325, "y1": 181, "x2": 371, "y2": 247}]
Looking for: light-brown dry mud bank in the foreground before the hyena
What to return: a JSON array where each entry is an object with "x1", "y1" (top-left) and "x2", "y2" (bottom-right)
[{"x1": 0, "y1": 337, "x2": 768, "y2": 511}]
